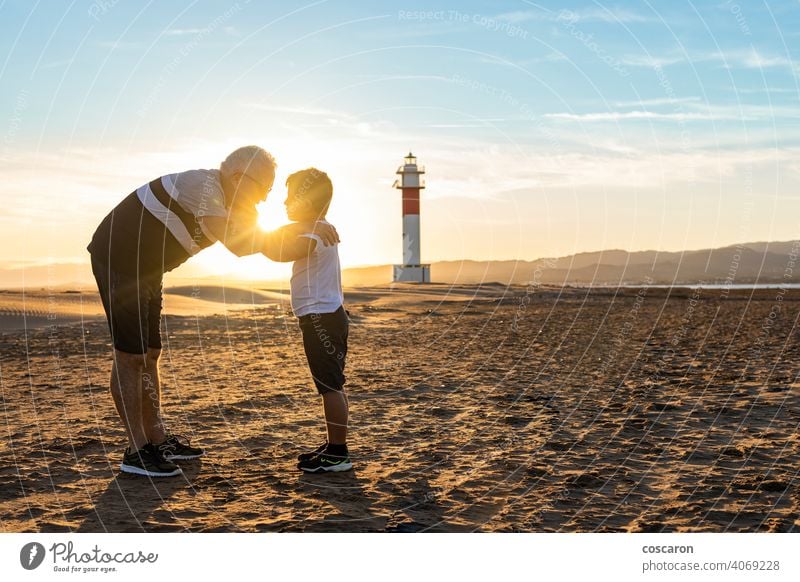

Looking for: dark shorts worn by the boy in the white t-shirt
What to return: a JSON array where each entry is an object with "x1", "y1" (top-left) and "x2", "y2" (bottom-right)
[{"x1": 299, "y1": 307, "x2": 348, "y2": 394}]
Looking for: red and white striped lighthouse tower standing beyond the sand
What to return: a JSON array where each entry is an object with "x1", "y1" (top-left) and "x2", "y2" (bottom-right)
[{"x1": 394, "y1": 152, "x2": 431, "y2": 283}]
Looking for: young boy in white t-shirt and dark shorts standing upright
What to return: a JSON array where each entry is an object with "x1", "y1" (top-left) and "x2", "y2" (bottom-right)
[{"x1": 267, "y1": 168, "x2": 353, "y2": 473}]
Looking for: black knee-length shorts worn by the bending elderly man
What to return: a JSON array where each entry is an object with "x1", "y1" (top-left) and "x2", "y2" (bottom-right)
[{"x1": 92, "y1": 256, "x2": 163, "y2": 354}]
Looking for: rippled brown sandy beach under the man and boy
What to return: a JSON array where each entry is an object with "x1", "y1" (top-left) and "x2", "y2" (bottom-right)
[{"x1": 0, "y1": 284, "x2": 800, "y2": 532}]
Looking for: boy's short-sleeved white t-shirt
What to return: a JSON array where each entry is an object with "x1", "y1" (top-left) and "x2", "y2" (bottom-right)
[{"x1": 291, "y1": 221, "x2": 344, "y2": 317}]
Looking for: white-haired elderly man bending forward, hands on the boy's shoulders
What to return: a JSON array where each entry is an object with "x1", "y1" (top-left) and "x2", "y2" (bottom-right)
[{"x1": 88, "y1": 146, "x2": 338, "y2": 477}]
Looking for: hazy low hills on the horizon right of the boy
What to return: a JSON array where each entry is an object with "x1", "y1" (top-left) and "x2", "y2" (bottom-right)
[{"x1": 342, "y1": 241, "x2": 800, "y2": 286}]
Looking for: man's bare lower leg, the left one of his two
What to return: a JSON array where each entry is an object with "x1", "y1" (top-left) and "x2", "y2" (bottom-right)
[{"x1": 111, "y1": 350, "x2": 148, "y2": 451}]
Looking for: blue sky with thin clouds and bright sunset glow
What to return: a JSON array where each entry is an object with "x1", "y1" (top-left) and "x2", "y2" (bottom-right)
[{"x1": 0, "y1": 0, "x2": 800, "y2": 276}]
